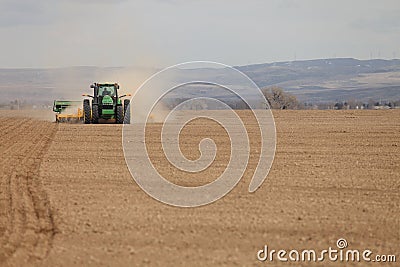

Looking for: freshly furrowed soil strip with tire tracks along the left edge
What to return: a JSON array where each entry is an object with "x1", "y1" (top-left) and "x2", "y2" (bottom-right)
[{"x1": 0, "y1": 117, "x2": 57, "y2": 266}]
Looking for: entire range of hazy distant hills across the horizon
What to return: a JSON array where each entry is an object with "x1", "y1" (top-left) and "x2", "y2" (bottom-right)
[{"x1": 0, "y1": 58, "x2": 400, "y2": 106}]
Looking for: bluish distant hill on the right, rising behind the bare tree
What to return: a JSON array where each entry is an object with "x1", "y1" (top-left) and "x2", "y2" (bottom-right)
[{"x1": 236, "y1": 58, "x2": 400, "y2": 102}]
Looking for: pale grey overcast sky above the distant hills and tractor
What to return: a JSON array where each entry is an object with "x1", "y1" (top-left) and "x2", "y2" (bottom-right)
[{"x1": 0, "y1": 0, "x2": 400, "y2": 68}]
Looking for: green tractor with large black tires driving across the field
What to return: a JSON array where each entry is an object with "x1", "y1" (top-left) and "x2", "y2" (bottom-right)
[{"x1": 82, "y1": 83, "x2": 131, "y2": 124}]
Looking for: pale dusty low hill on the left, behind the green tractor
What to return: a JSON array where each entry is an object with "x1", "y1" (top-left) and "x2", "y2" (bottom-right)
[{"x1": 0, "y1": 67, "x2": 154, "y2": 104}]
